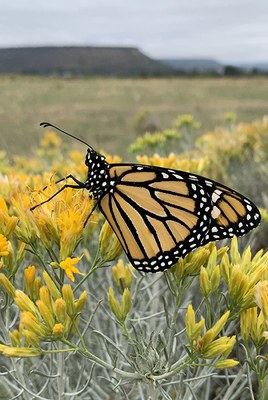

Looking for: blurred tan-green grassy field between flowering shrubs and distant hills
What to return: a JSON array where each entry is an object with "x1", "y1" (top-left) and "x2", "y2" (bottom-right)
[{"x1": 0, "y1": 76, "x2": 268, "y2": 154}]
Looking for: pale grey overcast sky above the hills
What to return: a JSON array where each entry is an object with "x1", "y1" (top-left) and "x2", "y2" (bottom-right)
[{"x1": 0, "y1": 0, "x2": 268, "y2": 62}]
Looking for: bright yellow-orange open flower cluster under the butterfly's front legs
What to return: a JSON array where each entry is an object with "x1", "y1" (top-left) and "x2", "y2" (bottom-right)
[{"x1": 8, "y1": 183, "x2": 97, "y2": 260}]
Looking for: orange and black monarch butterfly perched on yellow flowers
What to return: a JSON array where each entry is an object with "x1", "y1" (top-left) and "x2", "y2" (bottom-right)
[{"x1": 32, "y1": 122, "x2": 261, "y2": 272}]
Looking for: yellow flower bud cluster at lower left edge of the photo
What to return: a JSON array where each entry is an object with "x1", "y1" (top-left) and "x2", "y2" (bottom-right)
[{"x1": 0, "y1": 266, "x2": 87, "y2": 357}]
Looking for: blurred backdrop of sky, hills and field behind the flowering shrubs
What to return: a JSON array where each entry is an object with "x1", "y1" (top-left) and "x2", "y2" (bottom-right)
[{"x1": 0, "y1": 0, "x2": 268, "y2": 158}]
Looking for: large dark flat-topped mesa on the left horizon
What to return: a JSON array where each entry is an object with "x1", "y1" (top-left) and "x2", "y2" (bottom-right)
[{"x1": 0, "y1": 47, "x2": 173, "y2": 76}]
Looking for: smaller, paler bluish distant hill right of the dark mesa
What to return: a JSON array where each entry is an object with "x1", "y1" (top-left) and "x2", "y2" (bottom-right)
[{"x1": 158, "y1": 58, "x2": 224, "y2": 74}]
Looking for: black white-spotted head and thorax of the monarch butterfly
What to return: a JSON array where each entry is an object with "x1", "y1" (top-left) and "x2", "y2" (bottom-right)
[{"x1": 85, "y1": 149, "x2": 111, "y2": 200}]
